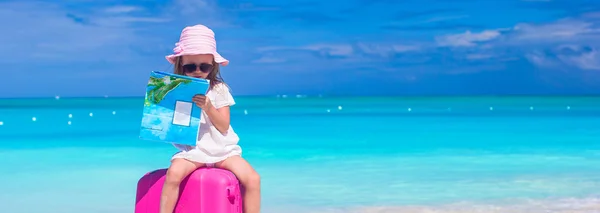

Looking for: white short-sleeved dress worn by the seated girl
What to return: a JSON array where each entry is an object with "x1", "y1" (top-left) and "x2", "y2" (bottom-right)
[{"x1": 171, "y1": 83, "x2": 242, "y2": 165}]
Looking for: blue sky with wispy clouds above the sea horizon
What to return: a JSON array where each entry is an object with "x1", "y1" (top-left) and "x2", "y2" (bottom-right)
[{"x1": 0, "y1": 0, "x2": 600, "y2": 97}]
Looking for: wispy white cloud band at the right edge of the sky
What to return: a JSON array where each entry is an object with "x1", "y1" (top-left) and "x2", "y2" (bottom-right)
[{"x1": 436, "y1": 12, "x2": 600, "y2": 70}]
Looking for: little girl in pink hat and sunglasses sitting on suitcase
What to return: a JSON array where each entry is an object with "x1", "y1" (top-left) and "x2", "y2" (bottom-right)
[{"x1": 160, "y1": 25, "x2": 260, "y2": 213}]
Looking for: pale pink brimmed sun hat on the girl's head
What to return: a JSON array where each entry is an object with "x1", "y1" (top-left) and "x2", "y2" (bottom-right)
[{"x1": 165, "y1": 24, "x2": 229, "y2": 66}]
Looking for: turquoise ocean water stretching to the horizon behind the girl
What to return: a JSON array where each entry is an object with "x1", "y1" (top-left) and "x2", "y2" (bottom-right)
[{"x1": 0, "y1": 97, "x2": 600, "y2": 213}]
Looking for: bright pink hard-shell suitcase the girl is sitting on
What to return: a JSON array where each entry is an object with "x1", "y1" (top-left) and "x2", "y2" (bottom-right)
[{"x1": 135, "y1": 167, "x2": 242, "y2": 213}]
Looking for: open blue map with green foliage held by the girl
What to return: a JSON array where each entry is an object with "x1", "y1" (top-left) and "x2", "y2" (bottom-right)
[{"x1": 140, "y1": 71, "x2": 209, "y2": 146}]
